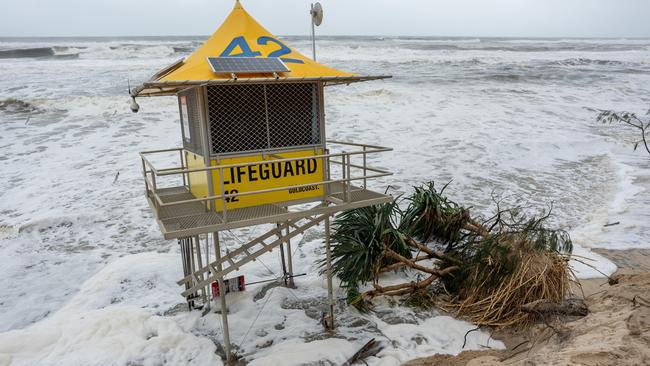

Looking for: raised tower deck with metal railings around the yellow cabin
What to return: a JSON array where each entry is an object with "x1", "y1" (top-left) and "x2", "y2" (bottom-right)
[{"x1": 140, "y1": 141, "x2": 392, "y2": 239}]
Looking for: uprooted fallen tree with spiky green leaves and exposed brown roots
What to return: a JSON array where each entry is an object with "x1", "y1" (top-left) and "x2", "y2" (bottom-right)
[{"x1": 332, "y1": 182, "x2": 573, "y2": 326}]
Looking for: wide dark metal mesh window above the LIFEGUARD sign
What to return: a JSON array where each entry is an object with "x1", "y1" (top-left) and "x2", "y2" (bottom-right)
[{"x1": 208, "y1": 83, "x2": 320, "y2": 154}]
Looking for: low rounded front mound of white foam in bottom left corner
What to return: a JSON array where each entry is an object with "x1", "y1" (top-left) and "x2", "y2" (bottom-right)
[{"x1": 0, "y1": 306, "x2": 221, "y2": 365}]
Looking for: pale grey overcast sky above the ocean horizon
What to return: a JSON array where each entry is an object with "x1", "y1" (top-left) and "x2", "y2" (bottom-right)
[{"x1": 0, "y1": 0, "x2": 650, "y2": 37}]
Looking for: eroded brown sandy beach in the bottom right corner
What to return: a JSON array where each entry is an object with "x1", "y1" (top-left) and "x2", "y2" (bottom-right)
[{"x1": 406, "y1": 249, "x2": 650, "y2": 366}]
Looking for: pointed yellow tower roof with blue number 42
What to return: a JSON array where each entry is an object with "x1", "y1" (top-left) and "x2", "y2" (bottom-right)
[{"x1": 131, "y1": 1, "x2": 390, "y2": 97}]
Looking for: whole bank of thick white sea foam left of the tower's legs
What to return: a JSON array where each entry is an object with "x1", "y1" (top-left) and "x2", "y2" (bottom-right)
[{"x1": 0, "y1": 253, "x2": 221, "y2": 366}]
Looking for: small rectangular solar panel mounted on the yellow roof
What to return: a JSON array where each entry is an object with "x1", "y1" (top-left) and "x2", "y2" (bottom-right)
[{"x1": 208, "y1": 57, "x2": 289, "y2": 74}]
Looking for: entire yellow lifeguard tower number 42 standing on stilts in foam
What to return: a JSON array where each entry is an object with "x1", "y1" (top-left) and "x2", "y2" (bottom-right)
[{"x1": 131, "y1": 1, "x2": 392, "y2": 359}]
